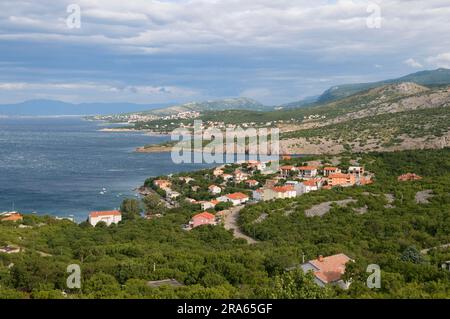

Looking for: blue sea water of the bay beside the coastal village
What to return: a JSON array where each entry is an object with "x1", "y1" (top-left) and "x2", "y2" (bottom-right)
[{"x1": 0, "y1": 117, "x2": 211, "y2": 221}]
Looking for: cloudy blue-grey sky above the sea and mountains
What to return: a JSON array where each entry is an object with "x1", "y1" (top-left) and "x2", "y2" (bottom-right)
[{"x1": 0, "y1": 0, "x2": 450, "y2": 105}]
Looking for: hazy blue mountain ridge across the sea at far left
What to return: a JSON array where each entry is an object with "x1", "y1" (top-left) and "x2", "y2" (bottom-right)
[{"x1": 0, "y1": 100, "x2": 164, "y2": 116}]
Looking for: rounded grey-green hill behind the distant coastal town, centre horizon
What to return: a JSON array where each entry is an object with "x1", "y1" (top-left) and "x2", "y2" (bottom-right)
[{"x1": 135, "y1": 97, "x2": 273, "y2": 116}]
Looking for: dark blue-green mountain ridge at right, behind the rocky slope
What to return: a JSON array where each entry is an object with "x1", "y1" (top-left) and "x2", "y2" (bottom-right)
[{"x1": 317, "y1": 68, "x2": 450, "y2": 103}]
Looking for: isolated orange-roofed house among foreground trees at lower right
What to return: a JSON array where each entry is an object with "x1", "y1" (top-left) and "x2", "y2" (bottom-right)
[{"x1": 301, "y1": 254, "x2": 351, "y2": 289}]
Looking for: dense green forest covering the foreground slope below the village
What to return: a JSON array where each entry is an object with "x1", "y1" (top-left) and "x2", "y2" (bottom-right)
[{"x1": 0, "y1": 148, "x2": 450, "y2": 298}]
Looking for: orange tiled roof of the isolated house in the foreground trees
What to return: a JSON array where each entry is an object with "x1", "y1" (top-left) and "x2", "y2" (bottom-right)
[{"x1": 309, "y1": 254, "x2": 351, "y2": 283}]
